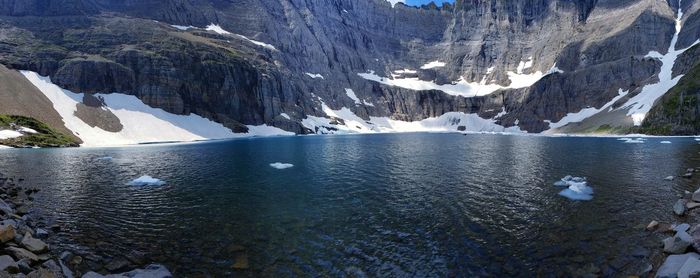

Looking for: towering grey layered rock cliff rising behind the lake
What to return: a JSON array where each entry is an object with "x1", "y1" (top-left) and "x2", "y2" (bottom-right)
[{"x1": 0, "y1": 0, "x2": 700, "y2": 133}]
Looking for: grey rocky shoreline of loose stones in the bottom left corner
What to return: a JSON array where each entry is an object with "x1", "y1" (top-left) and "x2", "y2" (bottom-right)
[{"x1": 0, "y1": 173, "x2": 173, "y2": 278}]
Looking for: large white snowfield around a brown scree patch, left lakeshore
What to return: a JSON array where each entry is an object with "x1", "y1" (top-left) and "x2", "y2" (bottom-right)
[{"x1": 22, "y1": 71, "x2": 293, "y2": 146}]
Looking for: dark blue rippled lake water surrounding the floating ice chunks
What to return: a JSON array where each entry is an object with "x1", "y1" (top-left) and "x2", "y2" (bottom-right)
[{"x1": 0, "y1": 134, "x2": 700, "y2": 277}]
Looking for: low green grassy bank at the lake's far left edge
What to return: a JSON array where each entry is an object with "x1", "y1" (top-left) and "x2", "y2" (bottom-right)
[{"x1": 0, "y1": 114, "x2": 78, "y2": 147}]
